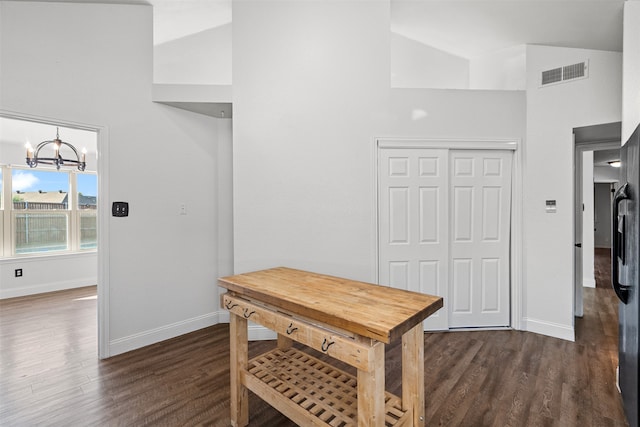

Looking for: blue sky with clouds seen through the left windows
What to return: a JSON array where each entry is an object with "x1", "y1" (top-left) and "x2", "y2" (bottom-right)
[{"x1": 12, "y1": 169, "x2": 97, "y2": 196}]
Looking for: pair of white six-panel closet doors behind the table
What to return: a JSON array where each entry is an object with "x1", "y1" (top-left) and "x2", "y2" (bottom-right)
[{"x1": 377, "y1": 140, "x2": 515, "y2": 330}]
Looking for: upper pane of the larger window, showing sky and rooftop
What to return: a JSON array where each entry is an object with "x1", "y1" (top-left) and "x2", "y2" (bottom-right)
[{"x1": 11, "y1": 169, "x2": 69, "y2": 210}]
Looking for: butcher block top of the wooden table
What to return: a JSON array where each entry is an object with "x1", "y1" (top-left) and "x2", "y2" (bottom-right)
[{"x1": 218, "y1": 267, "x2": 443, "y2": 344}]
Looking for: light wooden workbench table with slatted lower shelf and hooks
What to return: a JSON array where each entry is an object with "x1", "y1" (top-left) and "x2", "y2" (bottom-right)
[{"x1": 218, "y1": 267, "x2": 442, "y2": 427}]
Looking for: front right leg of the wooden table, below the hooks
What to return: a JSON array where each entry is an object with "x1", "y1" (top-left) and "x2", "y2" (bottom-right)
[{"x1": 358, "y1": 342, "x2": 385, "y2": 427}]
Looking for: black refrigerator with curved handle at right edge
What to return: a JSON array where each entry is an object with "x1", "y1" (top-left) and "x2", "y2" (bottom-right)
[{"x1": 611, "y1": 126, "x2": 640, "y2": 427}]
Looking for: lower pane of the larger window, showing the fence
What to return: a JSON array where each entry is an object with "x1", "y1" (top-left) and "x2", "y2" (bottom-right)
[{"x1": 15, "y1": 211, "x2": 69, "y2": 254}]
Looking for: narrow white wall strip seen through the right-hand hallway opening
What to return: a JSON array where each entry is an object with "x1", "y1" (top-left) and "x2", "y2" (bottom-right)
[{"x1": 582, "y1": 151, "x2": 596, "y2": 288}]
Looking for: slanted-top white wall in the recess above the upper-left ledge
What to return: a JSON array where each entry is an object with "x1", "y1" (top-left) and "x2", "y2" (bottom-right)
[{"x1": 153, "y1": 24, "x2": 231, "y2": 85}]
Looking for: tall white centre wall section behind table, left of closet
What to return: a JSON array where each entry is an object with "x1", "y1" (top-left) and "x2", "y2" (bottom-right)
[{"x1": 233, "y1": 1, "x2": 390, "y2": 281}]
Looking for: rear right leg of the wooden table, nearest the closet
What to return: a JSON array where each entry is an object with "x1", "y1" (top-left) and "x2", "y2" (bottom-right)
[{"x1": 402, "y1": 322, "x2": 425, "y2": 427}]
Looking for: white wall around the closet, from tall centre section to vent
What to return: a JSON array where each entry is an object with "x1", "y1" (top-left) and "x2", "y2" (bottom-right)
[{"x1": 233, "y1": 2, "x2": 621, "y2": 339}]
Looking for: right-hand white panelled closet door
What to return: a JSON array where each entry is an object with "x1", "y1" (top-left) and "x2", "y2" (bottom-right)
[{"x1": 449, "y1": 150, "x2": 512, "y2": 328}]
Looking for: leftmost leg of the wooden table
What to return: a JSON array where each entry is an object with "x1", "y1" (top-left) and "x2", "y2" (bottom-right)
[{"x1": 229, "y1": 313, "x2": 249, "y2": 427}]
